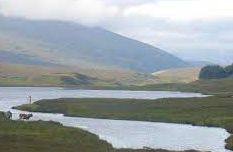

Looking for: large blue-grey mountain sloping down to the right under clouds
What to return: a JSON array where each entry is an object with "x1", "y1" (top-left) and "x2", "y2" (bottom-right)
[{"x1": 0, "y1": 16, "x2": 188, "y2": 73}]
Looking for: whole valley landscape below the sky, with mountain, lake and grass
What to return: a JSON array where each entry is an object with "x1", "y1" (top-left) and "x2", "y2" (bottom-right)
[{"x1": 0, "y1": 11, "x2": 233, "y2": 152}]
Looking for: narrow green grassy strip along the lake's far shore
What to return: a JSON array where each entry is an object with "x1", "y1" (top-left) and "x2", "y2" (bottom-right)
[{"x1": 0, "y1": 78, "x2": 233, "y2": 96}]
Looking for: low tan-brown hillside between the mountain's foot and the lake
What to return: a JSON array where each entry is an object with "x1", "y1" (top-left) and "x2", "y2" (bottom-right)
[{"x1": 0, "y1": 62, "x2": 159, "y2": 88}]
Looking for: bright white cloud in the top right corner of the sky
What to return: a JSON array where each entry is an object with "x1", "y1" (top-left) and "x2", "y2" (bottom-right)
[{"x1": 124, "y1": 0, "x2": 233, "y2": 21}]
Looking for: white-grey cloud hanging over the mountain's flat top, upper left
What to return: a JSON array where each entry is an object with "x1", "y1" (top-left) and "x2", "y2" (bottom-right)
[{"x1": 0, "y1": 0, "x2": 119, "y2": 24}]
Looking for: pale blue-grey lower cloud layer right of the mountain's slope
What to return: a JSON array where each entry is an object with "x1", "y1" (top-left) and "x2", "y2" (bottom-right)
[{"x1": 114, "y1": 18, "x2": 233, "y2": 64}]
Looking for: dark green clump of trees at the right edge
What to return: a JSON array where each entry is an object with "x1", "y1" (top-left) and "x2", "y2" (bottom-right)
[{"x1": 199, "y1": 64, "x2": 233, "y2": 79}]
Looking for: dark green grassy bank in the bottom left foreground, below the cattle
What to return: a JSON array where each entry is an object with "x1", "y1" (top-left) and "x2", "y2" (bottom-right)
[{"x1": 0, "y1": 113, "x2": 197, "y2": 152}]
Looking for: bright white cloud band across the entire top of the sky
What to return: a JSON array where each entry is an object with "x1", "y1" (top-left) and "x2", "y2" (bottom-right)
[{"x1": 0, "y1": 0, "x2": 233, "y2": 24}]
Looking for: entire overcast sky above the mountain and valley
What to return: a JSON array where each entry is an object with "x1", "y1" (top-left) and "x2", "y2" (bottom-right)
[{"x1": 0, "y1": 0, "x2": 233, "y2": 63}]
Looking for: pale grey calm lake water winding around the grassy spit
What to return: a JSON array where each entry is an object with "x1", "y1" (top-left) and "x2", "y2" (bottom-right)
[{"x1": 0, "y1": 87, "x2": 229, "y2": 152}]
